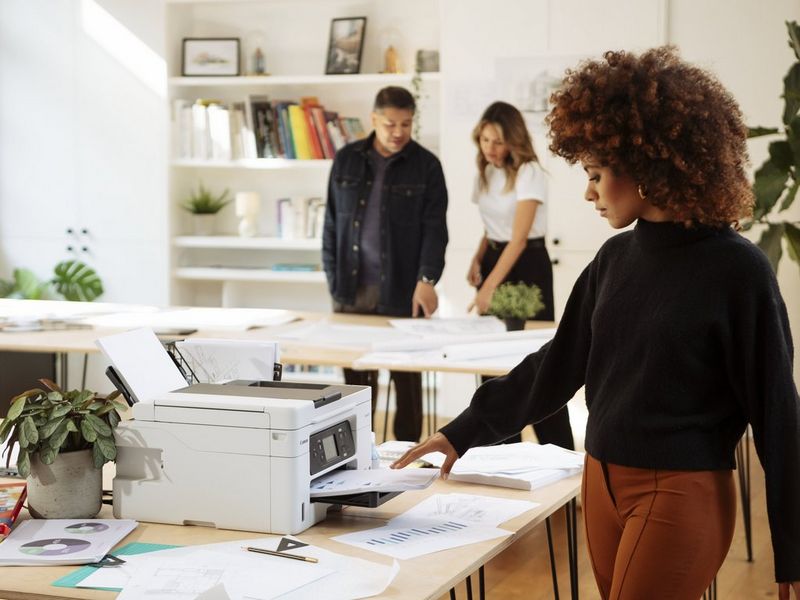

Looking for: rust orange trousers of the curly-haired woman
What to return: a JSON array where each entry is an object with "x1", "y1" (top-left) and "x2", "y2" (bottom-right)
[{"x1": 581, "y1": 454, "x2": 736, "y2": 600}]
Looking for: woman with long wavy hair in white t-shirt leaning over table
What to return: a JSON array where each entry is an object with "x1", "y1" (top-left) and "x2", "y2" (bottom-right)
[{"x1": 467, "y1": 102, "x2": 575, "y2": 450}]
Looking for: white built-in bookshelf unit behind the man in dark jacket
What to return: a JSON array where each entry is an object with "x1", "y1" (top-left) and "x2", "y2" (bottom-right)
[{"x1": 166, "y1": 0, "x2": 440, "y2": 310}]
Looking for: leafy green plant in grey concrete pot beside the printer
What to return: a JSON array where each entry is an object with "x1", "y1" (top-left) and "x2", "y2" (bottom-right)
[{"x1": 0, "y1": 379, "x2": 127, "y2": 519}]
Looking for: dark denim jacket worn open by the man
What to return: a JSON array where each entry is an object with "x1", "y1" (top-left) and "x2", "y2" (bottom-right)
[{"x1": 322, "y1": 132, "x2": 447, "y2": 316}]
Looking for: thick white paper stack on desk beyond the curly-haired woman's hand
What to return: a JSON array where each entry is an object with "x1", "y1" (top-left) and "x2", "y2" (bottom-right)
[{"x1": 426, "y1": 442, "x2": 584, "y2": 490}]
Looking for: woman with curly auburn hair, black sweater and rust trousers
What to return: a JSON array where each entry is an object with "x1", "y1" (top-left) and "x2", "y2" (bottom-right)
[{"x1": 393, "y1": 48, "x2": 800, "y2": 600}]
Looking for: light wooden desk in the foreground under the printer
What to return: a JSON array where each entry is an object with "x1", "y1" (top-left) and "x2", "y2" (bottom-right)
[{"x1": 0, "y1": 476, "x2": 581, "y2": 600}]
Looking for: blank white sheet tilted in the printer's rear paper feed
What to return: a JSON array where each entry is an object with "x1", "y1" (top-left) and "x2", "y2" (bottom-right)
[{"x1": 95, "y1": 328, "x2": 187, "y2": 402}]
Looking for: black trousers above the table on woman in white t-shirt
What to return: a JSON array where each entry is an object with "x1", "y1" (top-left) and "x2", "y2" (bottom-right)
[{"x1": 481, "y1": 238, "x2": 555, "y2": 321}]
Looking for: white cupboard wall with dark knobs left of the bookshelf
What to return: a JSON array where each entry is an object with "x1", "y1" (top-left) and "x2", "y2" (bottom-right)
[{"x1": 0, "y1": 0, "x2": 168, "y2": 303}]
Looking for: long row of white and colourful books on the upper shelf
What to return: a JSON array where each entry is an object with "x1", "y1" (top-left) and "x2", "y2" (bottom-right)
[{"x1": 173, "y1": 94, "x2": 366, "y2": 160}]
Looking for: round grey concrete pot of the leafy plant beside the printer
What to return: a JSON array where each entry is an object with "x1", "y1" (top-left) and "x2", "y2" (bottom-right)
[{"x1": 28, "y1": 450, "x2": 103, "y2": 519}]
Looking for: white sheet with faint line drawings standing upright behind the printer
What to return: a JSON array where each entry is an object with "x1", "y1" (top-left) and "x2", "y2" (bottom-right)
[{"x1": 175, "y1": 338, "x2": 279, "y2": 383}]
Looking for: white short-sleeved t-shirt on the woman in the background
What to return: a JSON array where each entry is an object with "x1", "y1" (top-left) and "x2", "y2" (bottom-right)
[{"x1": 472, "y1": 162, "x2": 547, "y2": 242}]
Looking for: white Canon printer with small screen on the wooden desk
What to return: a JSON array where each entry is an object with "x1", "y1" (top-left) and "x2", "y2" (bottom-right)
[{"x1": 98, "y1": 330, "x2": 376, "y2": 534}]
